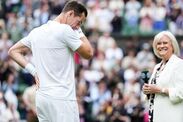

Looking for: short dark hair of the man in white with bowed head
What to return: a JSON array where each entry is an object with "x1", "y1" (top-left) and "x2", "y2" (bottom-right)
[{"x1": 62, "y1": 1, "x2": 88, "y2": 17}]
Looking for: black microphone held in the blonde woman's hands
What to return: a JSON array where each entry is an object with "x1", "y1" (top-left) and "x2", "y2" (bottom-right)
[{"x1": 140, "y1": 70, "x2": 150, "y2": 99}]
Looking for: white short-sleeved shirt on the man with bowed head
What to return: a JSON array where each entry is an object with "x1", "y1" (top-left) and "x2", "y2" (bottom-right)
[{"x1": 20, "y1": 21, "x2": 82, "y2": 100}]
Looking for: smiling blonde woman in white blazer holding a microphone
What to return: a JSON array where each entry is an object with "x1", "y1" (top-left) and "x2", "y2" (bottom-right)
[{"x1": 142, "y1": 31, "x2": 183, "y2": 122}]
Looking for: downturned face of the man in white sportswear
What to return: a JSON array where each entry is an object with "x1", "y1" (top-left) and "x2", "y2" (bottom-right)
[{"x1": 67, "y1": 12, "x2": 86, "y2": 30}]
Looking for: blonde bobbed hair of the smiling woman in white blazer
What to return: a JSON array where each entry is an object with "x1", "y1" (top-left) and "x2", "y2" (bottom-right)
[{"x1": 153, "y1": 31, "x2": 180, "y2": 58}]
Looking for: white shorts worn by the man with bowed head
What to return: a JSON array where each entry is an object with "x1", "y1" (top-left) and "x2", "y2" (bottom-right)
[{"x1": 36, "y1": 94, "x2": 79, "y2": 122}]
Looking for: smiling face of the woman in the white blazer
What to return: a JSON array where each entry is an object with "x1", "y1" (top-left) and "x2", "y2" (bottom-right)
[{"x1": 156, "y1": 36, "x2": 173, "y2": 60}]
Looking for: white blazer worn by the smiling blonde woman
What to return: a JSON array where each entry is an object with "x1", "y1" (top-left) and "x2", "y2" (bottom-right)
[{"x1": 149, "y1": 54, "x2": 183, "y2": 122}]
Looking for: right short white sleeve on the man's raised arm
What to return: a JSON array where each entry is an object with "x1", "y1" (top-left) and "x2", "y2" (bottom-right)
[{"x1": 64, "y1": 26, "x2": 82, "y2": 51}]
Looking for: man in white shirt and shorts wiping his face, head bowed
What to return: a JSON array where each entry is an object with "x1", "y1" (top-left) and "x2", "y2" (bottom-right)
[{"x1": 9, "y1": 1, "x2": 93, "y2": 122}]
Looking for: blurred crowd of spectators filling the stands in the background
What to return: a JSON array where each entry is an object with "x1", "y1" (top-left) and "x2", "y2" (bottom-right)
[{"x1": 0, "y1": 0, "x2": 183, "y2": 122}]
